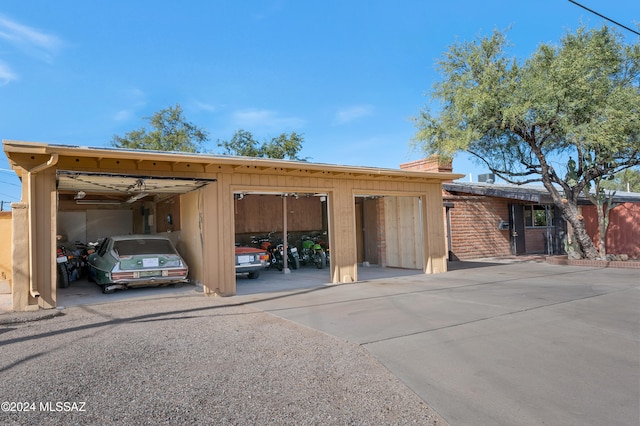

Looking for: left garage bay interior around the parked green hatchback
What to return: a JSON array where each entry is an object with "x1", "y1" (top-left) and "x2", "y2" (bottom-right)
[{"x1": 56, "y1": 170, "x2": 215, "y2": 306}]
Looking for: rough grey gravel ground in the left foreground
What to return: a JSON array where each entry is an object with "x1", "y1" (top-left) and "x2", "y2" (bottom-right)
[{"x1": 0, "y1": 294, "x2": 446, "y2": 425}]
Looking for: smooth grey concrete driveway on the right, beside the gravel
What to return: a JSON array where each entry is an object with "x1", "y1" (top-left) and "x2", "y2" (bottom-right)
[{"x1": 240, "y1": 262, "x2": 640, "y2": 425}]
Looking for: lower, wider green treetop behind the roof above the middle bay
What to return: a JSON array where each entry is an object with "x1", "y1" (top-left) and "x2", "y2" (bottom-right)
[{"x1": 218, "y1": 129, "x2": 304, "y2": 161}]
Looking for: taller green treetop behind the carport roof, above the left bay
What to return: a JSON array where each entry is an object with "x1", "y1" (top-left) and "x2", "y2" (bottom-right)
[{"x1": 111, "y1": 104, "x2": 208, "y2": 152}]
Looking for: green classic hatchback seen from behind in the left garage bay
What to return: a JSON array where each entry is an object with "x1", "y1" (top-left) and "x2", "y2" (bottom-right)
[{"x1": 87, "y1": 235, "x2": 189, "y2": 294}]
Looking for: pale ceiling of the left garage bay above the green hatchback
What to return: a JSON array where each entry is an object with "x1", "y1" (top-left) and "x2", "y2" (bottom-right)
[{"x1": 57, "y1": 170, "x2": 215, "y2": 201}]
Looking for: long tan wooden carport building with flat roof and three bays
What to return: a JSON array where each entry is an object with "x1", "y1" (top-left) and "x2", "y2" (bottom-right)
[{"x1": 3, "y1": 141, "x2": 461, "y2": 310}]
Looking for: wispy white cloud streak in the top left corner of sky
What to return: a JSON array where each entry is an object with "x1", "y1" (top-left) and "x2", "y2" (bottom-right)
[{"x1": 0, "y1": 15, "x2": 62, "y2": 62}]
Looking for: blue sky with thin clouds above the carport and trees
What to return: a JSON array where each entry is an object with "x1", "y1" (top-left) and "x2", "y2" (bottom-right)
[{"x1": 0, "y1": 0, "x2": 640, "y2": 205}]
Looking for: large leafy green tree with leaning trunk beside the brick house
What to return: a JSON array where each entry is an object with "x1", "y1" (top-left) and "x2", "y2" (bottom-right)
[{"x1": 413, "y1": 26, "x2": 640, "y2": 259}]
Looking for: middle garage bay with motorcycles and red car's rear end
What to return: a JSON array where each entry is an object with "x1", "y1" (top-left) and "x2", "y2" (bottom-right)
[{"x1": 234, "y1": 191, "x2": 331, "y2": 295}]
